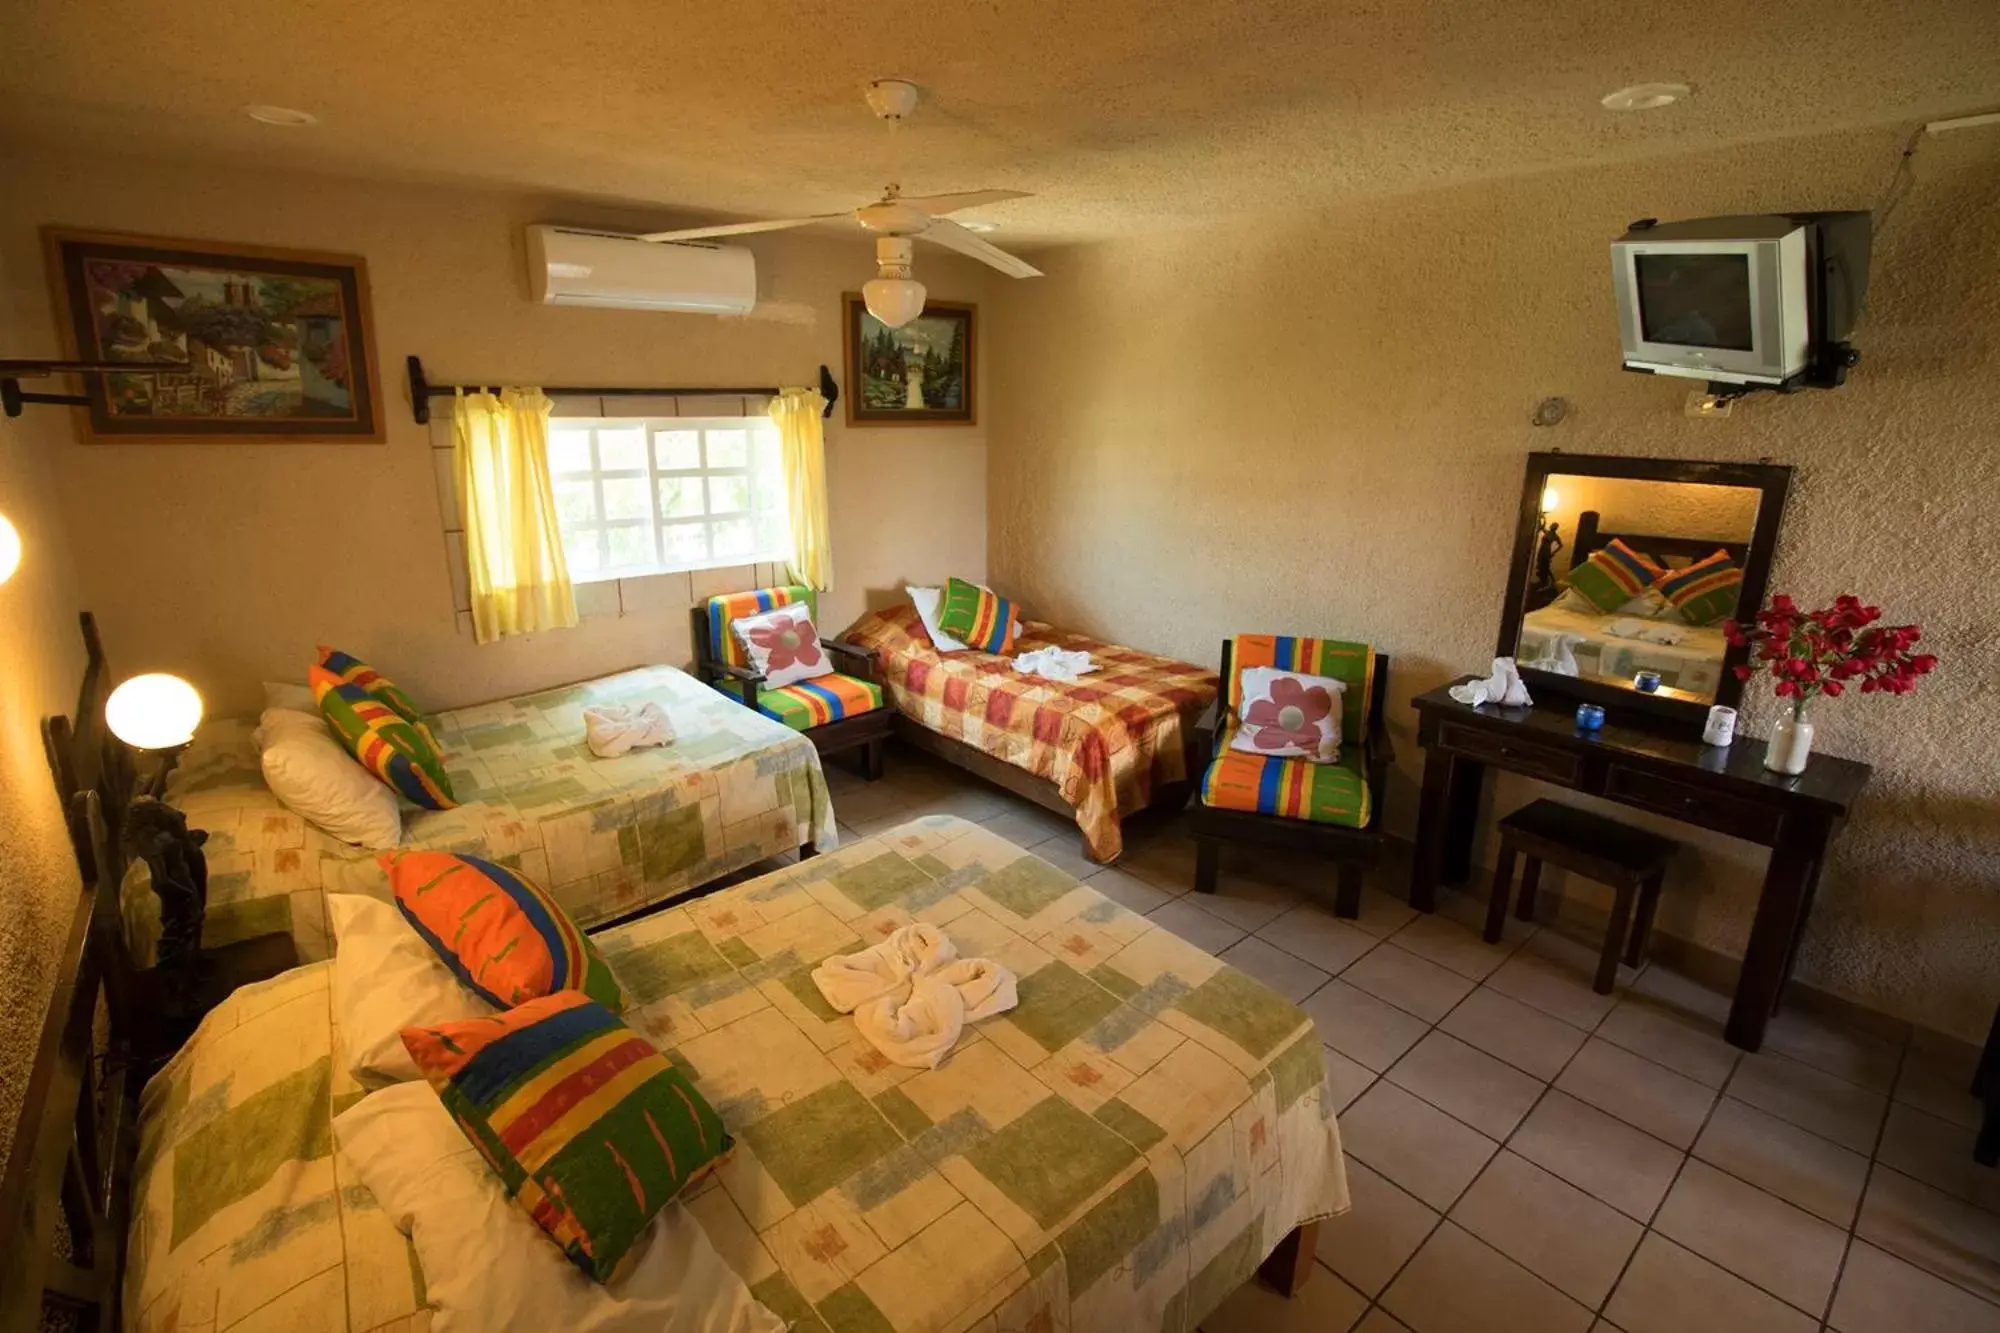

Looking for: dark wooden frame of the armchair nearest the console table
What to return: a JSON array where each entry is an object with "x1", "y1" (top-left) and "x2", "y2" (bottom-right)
[{"x1": 1188, "y1": 638, "x2": 1396, "y2": 919}]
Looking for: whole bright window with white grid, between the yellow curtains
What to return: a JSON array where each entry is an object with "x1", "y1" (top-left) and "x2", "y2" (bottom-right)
[{"x1": 548, "y1": 416, "x2": 792, "y2": 582}]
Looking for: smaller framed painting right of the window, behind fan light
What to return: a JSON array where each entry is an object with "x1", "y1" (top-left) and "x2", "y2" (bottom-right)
[{"x1": 844, "y1": 292, "x2": 980, "y2": 426}]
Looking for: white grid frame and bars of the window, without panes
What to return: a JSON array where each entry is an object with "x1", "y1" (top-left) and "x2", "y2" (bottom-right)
[{"x1": 548, "y1": 416, "x2": 792, "y2": 582}]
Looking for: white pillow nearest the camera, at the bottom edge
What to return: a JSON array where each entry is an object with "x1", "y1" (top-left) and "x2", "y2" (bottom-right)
[{"x1": 334, "y1": 1083, "x2": 784, "y2": 1333}]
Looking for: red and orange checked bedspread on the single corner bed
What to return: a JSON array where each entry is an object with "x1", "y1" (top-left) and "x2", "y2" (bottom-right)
[{"x1": 842, "y1": 604, "x2": 1218, "y2": 861}]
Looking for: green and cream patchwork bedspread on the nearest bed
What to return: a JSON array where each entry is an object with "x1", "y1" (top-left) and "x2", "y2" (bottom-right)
[{"x1": 128, "y1": 817, "x2": 1348, "y2": 1333}]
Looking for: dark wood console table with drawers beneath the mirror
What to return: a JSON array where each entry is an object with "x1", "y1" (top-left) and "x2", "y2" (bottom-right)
[{"x1": 1410, "y1": 677, "x2": 1870, "y2": 1051}]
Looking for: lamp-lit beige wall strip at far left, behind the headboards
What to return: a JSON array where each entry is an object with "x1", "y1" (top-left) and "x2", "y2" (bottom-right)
[{"x1": 0, "y1": 241, "x2": 84, "y2": 1163}]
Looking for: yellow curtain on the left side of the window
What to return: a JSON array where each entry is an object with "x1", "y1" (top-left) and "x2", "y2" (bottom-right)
[{"x1": 452, "y1": 388, "x2": 576, "y2": 642}]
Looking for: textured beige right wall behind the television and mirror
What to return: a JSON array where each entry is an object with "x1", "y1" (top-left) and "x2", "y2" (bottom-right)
[{"x1": 988, "y1": 130, "x2": 2000, "y2": 1035}]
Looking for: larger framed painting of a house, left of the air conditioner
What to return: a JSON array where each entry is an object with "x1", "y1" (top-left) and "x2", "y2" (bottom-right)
[{"x1": 42, "y1": 226, "x2": 384, "y2": 442}]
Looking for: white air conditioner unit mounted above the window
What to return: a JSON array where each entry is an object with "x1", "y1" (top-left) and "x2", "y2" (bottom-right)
[{"x1": 528, "y1": 226, "x2": 756, "y2": 314}]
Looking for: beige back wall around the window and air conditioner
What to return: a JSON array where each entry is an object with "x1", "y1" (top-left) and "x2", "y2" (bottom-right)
[{"x1": 0, "y1": 145, "x2": 986, "y2": 711}]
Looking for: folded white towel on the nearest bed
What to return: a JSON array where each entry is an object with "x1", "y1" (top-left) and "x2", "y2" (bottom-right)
[{"x1": 812, "y1": 921, "x2": 1018, "y2": 1069}]
